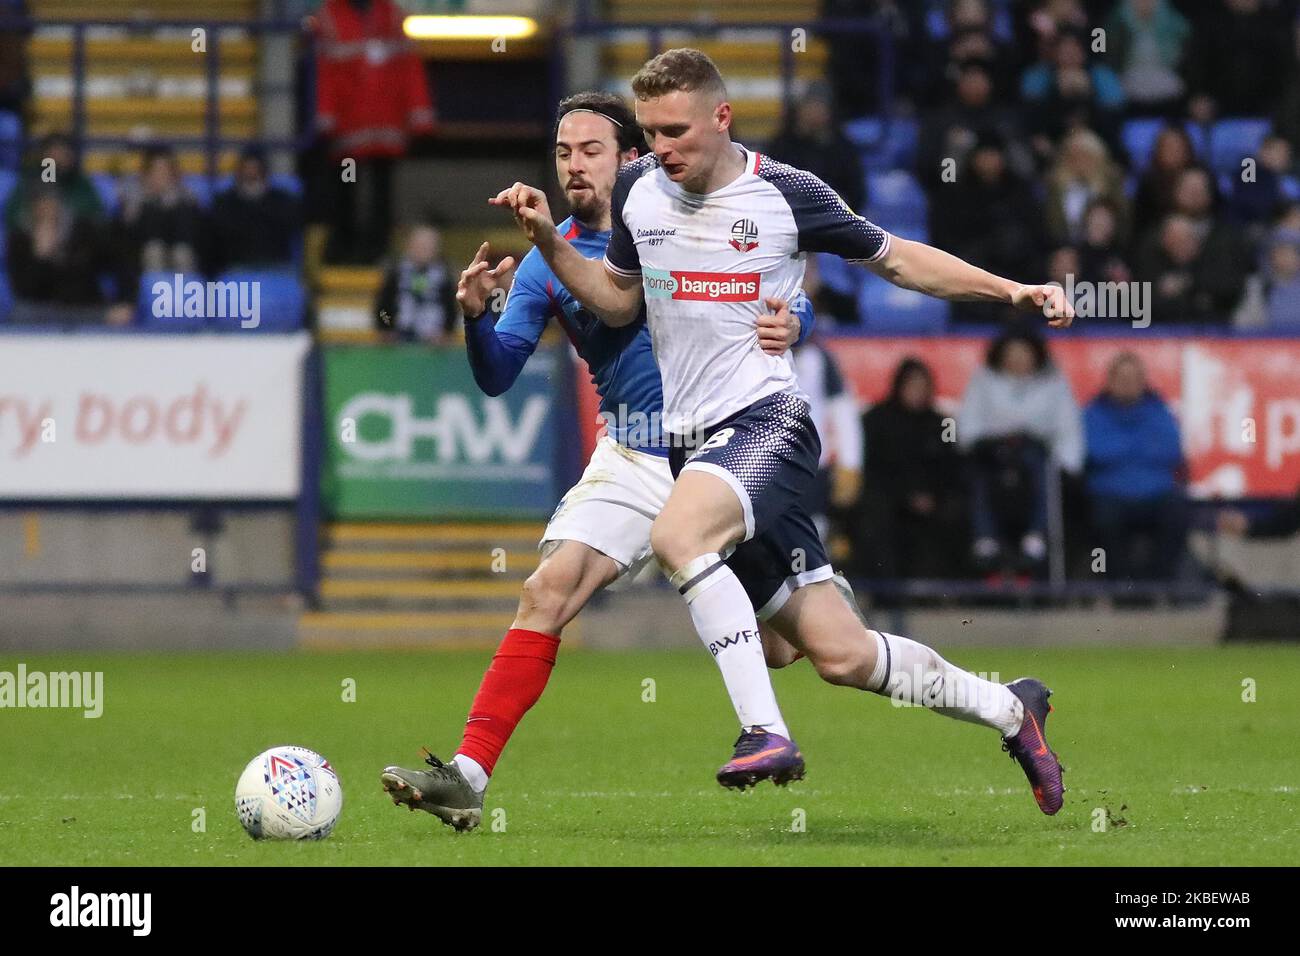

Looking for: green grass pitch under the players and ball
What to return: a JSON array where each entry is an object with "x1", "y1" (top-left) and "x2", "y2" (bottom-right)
[{"x1": 0, "y1": 646, "x2": 1300, "y2": 866}]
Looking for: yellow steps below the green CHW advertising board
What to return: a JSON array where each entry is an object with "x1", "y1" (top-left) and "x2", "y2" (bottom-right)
[{"x1": 298, "y1": 522, "x2": 548, "y2": 650}]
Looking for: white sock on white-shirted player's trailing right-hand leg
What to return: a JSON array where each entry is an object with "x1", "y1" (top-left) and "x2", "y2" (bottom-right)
[{"x1": 870, "y1": 631, "x2": 1024, "y2": 737}]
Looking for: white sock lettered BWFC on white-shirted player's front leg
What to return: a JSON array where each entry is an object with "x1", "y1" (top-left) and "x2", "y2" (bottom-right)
[{"x1": 668, "y1": 554, "x2": 790, "y2": 737}]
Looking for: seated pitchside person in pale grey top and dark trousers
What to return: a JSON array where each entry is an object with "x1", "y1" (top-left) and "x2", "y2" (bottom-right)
[{"x1": 961, "y1": 326, "x2": 1083, "y2": 572}]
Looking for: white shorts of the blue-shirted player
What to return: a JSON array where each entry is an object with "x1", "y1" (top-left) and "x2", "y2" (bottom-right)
[{"x1": 538, "y1": 434, "x2": 672, "y2": 574}]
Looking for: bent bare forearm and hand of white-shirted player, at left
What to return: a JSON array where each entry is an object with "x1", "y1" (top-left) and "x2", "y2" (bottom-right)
[{"x1": 488, "y1": 182, "x2": 641, "y2": 326}]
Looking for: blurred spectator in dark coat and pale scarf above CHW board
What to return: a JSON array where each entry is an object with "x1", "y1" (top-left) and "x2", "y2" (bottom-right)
[{"x1": 374, "y1": 224, "x2": 460, "y2": 342}]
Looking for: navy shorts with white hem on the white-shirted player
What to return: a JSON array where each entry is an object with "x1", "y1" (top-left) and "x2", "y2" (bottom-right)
[{"x1": 668, "y1": 392, "x2": 832, "y2": 620}]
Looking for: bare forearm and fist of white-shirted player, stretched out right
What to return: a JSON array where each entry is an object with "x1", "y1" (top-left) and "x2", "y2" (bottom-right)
[{"x1": 866, "y1": 235, "x2": 1074, "y2": 329}]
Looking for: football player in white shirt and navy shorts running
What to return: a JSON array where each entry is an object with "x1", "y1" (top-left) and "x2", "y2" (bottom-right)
[{"x1": 489, "y1": 49, "x2": 1074, "y2": 814}]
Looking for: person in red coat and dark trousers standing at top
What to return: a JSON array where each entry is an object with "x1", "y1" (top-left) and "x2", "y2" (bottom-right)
[{"x1": 316, "y1": 0, "x2": 434, "y2": 261}]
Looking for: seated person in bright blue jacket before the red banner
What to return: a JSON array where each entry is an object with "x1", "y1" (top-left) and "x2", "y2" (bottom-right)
[{"x1": 1083, "y1": 352, "x2": 1187, "y2": 580}]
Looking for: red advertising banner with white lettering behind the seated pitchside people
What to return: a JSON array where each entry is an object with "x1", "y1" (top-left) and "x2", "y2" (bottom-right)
[{"x1": 577, "y1": 336, "x2": 1300, "y2": 498}]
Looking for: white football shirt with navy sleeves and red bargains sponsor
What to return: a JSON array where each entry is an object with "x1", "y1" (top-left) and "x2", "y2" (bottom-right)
[{"x1": 605, "y1": 144, "x2": 889, "y2": 434}]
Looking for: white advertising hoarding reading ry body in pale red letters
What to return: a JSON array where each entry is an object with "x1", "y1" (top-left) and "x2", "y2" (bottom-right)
[{"x1": 0, "y1": 333, "x2": 311, "y2": 499}]
